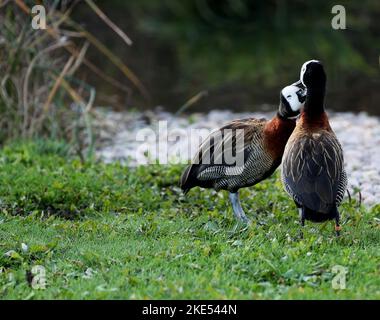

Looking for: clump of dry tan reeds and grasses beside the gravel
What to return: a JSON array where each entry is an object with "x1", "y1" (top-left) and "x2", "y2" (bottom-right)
[{"x1": 0, "y1": 0, "x2": 141, "y2": 155}]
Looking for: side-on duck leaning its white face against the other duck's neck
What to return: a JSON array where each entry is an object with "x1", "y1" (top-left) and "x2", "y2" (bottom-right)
[{"x1": 180, "y1": 81, "x2": 306, "y2": 223}]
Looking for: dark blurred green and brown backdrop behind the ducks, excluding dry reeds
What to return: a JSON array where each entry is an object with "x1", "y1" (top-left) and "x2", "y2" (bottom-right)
[{"x1": 75, "y1": 0, "x2": 380, "y2": 114}]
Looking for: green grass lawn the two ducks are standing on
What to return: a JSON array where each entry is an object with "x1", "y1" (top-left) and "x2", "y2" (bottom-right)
[{"x1": 0, "y1": 141, "x2": 380, "y2": 299}]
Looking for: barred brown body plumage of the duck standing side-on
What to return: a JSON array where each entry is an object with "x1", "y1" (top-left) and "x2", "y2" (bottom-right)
[{"x1": 181, "y1": 118, "x2": 280, "y2": 192}]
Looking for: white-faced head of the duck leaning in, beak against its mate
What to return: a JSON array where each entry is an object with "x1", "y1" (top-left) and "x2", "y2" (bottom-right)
[{"x1": 278, "y1": 81, "x2": 306, "y2": 119}]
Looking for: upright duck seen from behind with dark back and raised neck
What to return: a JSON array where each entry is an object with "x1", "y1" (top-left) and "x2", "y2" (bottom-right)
[{"x1": 281, "y1": 60, "x2": 347, "y2": 236}]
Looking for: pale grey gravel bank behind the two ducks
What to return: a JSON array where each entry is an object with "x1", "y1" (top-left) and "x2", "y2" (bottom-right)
[{"x1": 95, "y1": 109, "x2": 380, "y2": 205}]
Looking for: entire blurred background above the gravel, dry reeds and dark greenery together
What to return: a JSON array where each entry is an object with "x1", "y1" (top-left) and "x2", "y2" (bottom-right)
[{"x1": 0, "y1": 0, "x2": 380, "y2": 151}]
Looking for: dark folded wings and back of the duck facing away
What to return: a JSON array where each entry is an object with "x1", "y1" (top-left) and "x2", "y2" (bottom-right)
[{"x1": 281, "y1": 127, "x2": 347, "y2": 214}]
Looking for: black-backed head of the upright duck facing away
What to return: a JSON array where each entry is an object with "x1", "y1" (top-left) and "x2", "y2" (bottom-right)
[{"x1": 300, "y1": 60, "x2": 326, "y2": 89}]
